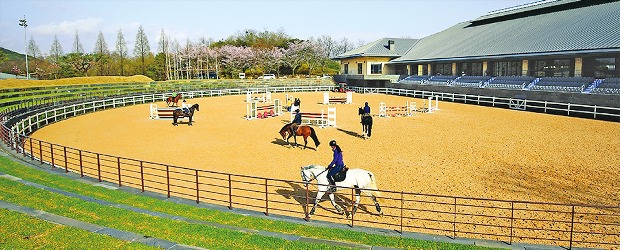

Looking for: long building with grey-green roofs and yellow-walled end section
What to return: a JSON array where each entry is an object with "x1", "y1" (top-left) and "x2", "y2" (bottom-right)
[{"x1": 334, "y1": 0, "x2": 620, "y2": 90}]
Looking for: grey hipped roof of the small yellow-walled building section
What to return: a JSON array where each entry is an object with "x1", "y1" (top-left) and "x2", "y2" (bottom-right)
[{"x1": 332, "y1": 38, "x2": 419, "y2": 60}]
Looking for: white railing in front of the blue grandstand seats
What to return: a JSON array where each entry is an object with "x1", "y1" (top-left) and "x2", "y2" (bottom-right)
[{"x1": 350, "y1": 87, "x2": 620, "y2": 122}]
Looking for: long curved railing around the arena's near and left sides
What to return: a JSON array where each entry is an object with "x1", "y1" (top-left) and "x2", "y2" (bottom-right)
[{"x1": 0, "y1": 87, "x2": 620, "y2": 249}]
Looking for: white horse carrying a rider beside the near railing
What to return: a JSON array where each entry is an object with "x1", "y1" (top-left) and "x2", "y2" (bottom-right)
[{"x1": 301, "y1": 165, "x2": 383, "y2": 218}]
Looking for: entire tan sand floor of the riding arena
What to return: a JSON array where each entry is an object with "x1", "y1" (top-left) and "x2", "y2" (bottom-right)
[{"x1": 17, "y1": 88, "x2": 620, "y2": 248}]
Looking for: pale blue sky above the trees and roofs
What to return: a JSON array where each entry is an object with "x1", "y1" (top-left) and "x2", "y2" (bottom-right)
[{"x1": 0, "y1": 0, "x2": 537, "y2": 55}]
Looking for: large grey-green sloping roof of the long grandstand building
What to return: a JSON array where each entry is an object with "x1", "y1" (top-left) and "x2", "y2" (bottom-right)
[{"x1": 392, "y1": 0, "x2": 620, "y2": 63}]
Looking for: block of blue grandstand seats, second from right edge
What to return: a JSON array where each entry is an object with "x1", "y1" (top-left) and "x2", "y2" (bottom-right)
[{"x1": 530, "y1": 77, "x2": 594, "y2": 93}]
